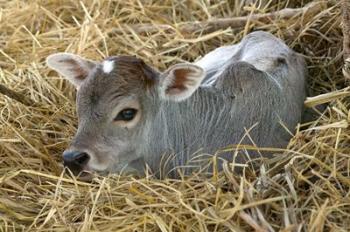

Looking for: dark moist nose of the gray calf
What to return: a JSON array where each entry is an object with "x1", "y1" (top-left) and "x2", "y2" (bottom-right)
[{"x1": 63, "y1": 151, "x2": 90, "y2": 175}]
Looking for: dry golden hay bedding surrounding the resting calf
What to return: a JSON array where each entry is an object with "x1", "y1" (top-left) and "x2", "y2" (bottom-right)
[{"x1": 0, "y1": 0, "x2": 350, "y2": 231}]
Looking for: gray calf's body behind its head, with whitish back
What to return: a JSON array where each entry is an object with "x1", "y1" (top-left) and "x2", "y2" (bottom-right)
[{"x1": 145, "y1": 32, "x2": 306, "y2": 175}]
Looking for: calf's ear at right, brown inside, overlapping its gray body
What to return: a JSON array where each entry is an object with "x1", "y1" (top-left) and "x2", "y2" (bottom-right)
[{"x1": 159, "y1": 64, "x2": 205, "y2": 101}]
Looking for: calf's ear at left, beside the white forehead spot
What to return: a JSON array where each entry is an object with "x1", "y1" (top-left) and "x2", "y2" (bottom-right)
[{"x1": 46, "y1": 53, "x2": 96, "y2": 89}]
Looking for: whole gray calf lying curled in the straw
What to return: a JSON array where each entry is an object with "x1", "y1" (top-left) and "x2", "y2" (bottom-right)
[{"x1": 47, "y1": 32, "x2": 306, "y2": 179}]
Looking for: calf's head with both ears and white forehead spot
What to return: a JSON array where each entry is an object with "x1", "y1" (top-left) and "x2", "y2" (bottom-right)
[{"x1": 47, "y1": 53, "x2": 204, "y2": 178}]
